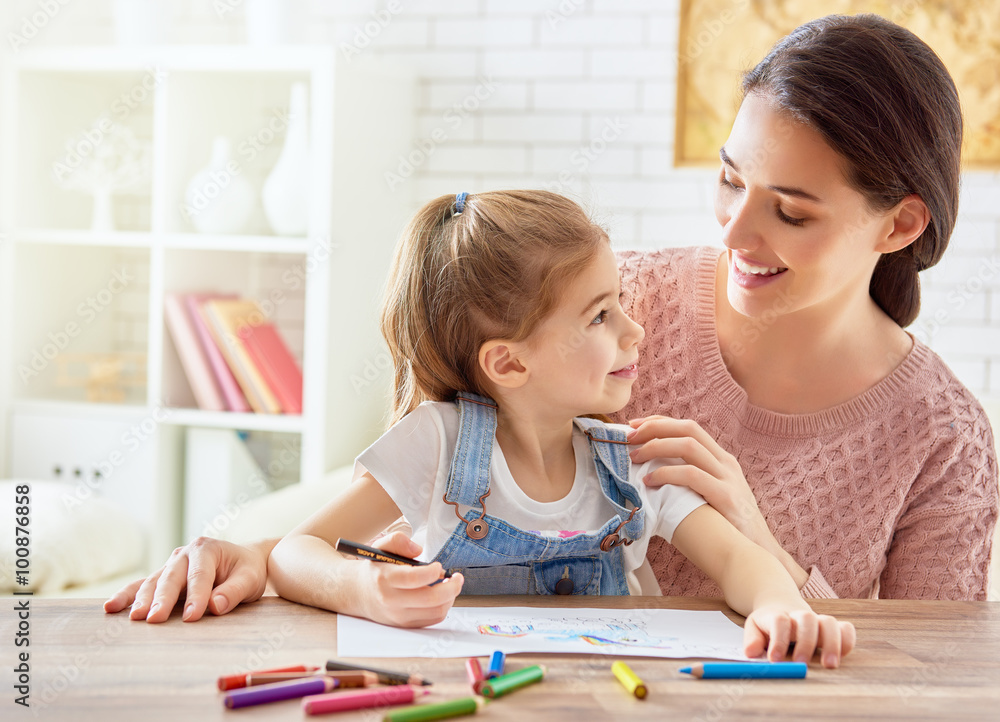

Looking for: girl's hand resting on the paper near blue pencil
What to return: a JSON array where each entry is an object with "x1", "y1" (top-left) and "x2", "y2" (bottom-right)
[{"x1": 743, "y1": 604, "x2": 857, "y2": 669}]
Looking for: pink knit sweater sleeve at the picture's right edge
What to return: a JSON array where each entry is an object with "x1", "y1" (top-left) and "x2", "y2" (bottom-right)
[{"x1": 879, "y1": 404, "x2": 998, "y2": 601}]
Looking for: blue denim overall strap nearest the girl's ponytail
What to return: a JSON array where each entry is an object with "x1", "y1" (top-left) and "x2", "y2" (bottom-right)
[{"x1": 445, "y1": 391, "x2": 497, "y2": 507}]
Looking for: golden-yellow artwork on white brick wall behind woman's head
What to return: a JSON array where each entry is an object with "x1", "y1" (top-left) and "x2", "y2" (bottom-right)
[{"x1": 674, "y1": 0, "x2": 1000, "y2": 170}]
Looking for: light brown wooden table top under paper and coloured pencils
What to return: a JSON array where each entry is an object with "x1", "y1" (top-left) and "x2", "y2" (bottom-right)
[{"x1": 13, "y1": 597, "x2": 1000, "y2": 722}]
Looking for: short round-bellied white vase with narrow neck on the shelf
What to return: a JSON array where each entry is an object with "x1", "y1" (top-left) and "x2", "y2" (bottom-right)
[{"x1": 184, "y1": 135, "x2": 256, "y2": 233}]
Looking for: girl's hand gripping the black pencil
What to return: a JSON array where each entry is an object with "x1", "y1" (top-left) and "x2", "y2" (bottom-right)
[{"x1": 358, "y1": 532, "x2": 464, "y2": 627}]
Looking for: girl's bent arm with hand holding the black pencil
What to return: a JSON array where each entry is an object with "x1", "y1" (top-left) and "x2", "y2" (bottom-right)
[{"x1": 267, "y1": 473, "x2": 463, "y2": 627}]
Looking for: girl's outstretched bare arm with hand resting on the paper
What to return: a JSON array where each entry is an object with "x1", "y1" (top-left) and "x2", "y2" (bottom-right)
[{"x1": 670, "y1": 505, "x2": 855, "y2": 668}]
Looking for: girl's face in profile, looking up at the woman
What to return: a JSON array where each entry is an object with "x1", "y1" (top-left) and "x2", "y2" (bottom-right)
[{"x1": 525, "y1": 244, "x2": 644, "y2": 418}]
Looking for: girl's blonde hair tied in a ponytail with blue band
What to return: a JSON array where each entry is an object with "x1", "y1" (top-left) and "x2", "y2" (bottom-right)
[{"x1": 381, "y1": 190, "x2": 608, "y2": 424}]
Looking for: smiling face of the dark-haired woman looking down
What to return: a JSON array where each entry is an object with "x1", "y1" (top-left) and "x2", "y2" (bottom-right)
[{"x1": 715, "y1": 94, "x2": 892, "y2": 321}]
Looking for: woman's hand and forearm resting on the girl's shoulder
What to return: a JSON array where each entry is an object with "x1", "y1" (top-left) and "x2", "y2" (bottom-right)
[{"x1": 628, "y1": 416, "x2": 809, "y2": 588}]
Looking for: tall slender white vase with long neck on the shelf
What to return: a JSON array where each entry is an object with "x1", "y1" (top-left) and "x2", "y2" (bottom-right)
[{"x1": 261, "y1": 83, "x2": 310, "y2": 236}]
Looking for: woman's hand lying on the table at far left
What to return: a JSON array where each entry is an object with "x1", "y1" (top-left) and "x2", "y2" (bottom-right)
[{"x1": 104, "y1": 537, "x2": 277, "y2": 622}]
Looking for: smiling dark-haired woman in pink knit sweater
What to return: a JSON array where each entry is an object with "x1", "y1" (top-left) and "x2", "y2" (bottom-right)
[{"x1": 105, "y1": 11, "x2": 997, "y2": 621}]
